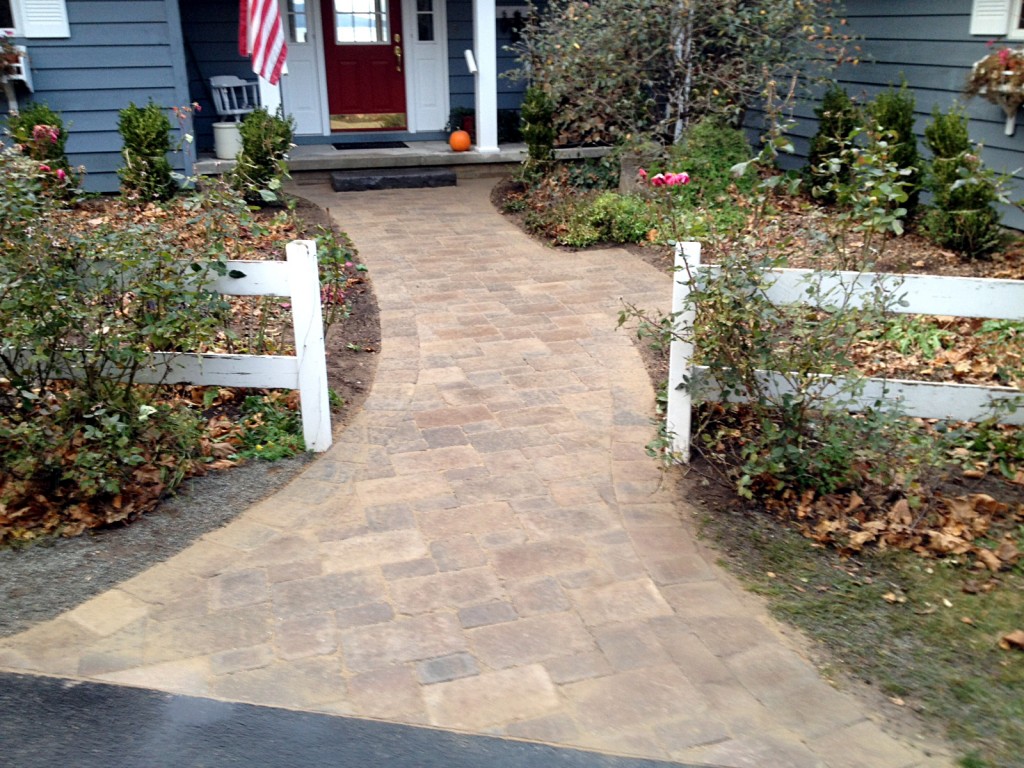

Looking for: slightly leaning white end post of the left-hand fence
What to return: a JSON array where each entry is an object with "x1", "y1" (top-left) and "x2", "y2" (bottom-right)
[{"x1": 286, "y1": 240, "x2": 331, "y2": 453}]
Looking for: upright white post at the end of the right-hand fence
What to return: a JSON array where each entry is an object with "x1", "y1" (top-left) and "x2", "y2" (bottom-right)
[{"x1": 665, "y1": 243, "x2": 700, "y2": 464}]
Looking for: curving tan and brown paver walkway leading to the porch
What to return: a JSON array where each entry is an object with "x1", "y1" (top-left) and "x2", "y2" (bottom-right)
[{"x1": 0, "y1": 180, "x2": 949, "y2": 768}]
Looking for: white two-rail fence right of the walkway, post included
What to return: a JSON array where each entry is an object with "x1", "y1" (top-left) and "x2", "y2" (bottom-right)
[{"x1": 666, "y1": 243, "x2": 1024, "y2": 461}]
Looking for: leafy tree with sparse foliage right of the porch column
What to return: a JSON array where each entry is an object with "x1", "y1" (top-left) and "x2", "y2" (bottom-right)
[{"x1": 519, "y1": 0, "x2": 847, "y2": 142}]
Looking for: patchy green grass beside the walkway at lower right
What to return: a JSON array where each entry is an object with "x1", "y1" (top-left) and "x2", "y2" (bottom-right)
[{"x1": 703, "y1": 501, "x2": 1024, "y2": 768}]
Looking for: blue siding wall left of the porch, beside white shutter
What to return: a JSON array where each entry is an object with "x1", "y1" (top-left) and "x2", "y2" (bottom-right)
[{"x1": 0, "y1": 0, "x2": 188, "y2": 191}]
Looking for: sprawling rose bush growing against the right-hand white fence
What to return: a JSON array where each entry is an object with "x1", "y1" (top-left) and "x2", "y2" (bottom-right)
[{"x1": 621, "y1": 246, "x2": 940, "y2": 498}]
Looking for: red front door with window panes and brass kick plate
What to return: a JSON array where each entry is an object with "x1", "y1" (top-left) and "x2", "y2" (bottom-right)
[{"x1": 321, "y1": 0, "x2": 407, "y2": 131}]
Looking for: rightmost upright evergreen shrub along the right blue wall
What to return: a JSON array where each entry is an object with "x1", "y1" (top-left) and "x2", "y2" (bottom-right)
[{"x1": 925, "y1": 104, "x2": 1006, "y2": 259}]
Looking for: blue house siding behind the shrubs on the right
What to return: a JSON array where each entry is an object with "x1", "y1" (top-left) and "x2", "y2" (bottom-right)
[{"x1": 770, "y1": 0, "x2": 1024, "y2": 229}]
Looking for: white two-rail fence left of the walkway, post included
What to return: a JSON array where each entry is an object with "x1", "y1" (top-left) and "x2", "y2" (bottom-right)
[{"x1": 128, "y1": 240, "x2": 331, "y2": 453}]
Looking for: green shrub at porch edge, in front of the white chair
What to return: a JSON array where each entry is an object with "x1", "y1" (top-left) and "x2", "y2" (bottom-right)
[{"x1": 228, "y1": 108, "x2": 295, "y2": 204}]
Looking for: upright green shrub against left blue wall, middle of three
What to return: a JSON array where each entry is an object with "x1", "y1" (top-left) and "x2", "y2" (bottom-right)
[{"x1": 118, "y1": 99, "x2": 178, "y2": 203}]
